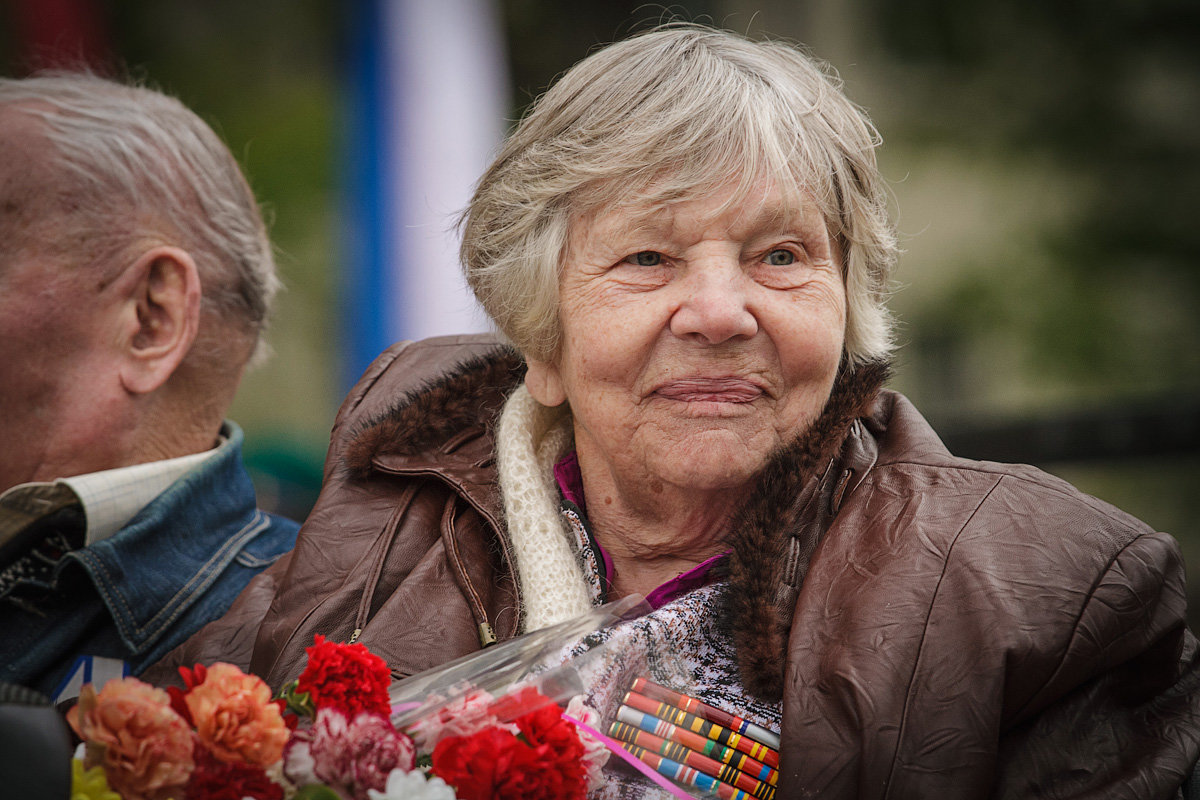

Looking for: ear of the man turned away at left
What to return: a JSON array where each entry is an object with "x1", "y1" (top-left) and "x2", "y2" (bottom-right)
[{"x1": 120, "y1": 247, "x2": 200, "y2": 395}]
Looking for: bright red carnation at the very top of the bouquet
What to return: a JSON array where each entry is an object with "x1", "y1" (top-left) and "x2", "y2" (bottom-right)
[{"x1": 296, "y1": 633, "x2": 391, "y2": 720}]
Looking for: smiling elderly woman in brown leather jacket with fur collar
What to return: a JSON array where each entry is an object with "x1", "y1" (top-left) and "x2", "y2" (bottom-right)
[{"x1": 171, "y1": 26, "x2": 1200, "y2": 800}]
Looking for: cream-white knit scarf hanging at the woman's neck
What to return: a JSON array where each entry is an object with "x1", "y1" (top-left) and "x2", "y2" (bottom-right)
[{"x1": 496, "y1": 385, "x2": 592, "y2": 632}]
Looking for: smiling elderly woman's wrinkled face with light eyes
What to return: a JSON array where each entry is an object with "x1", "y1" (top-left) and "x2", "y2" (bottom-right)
[{"x1": 526, "y1": 178, "x2": 846, "y2": 493}]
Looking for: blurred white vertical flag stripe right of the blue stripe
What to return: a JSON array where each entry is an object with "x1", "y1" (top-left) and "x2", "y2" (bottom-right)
[{"x1": 380, "y1": 0, "x2": 508, "y2": 338}]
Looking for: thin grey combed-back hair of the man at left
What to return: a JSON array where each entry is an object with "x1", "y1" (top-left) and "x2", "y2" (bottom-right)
[{"x1": 0, "y1": 72, "x2": 280, "y2": 367}]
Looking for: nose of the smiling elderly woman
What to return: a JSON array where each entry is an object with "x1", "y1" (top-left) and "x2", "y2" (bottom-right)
[{"x1": 671, "y1": 264, "x2": 758, "y2": 344}]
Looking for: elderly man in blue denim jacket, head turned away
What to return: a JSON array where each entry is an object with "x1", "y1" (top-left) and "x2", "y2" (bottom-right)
[{"x1": 0, "y1": 74, "x2": 298, "y2": 699}]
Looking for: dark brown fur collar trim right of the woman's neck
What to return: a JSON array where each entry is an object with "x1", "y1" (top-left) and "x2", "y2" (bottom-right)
[{"x1": 724, "y1": 362, "x2": 890, "y2": 702}]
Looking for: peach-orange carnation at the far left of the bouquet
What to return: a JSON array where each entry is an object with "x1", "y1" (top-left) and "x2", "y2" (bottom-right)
[{"x1": 67, "y1": 678, "x2": 194, "y2": 800}]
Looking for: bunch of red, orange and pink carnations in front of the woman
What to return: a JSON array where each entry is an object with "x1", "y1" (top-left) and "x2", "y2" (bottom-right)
[{"x1": 68, "y1": 636, "x2": 607, "y2": 800}]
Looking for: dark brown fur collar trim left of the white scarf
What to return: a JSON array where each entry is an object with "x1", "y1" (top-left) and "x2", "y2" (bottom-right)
[{"x1": 344, "y1": 347, "x2": 526, "y2": 479}]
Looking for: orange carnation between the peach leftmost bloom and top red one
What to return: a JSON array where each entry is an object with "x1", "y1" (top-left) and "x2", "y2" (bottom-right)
[{"x1": 184, "y1": 663, "x2": 289, "y2": 768}]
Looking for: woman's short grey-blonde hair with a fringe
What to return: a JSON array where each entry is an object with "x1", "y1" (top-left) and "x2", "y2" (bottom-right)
[{"x1": 462, "y1": 25, "x2": 898, "y2": 363}]
